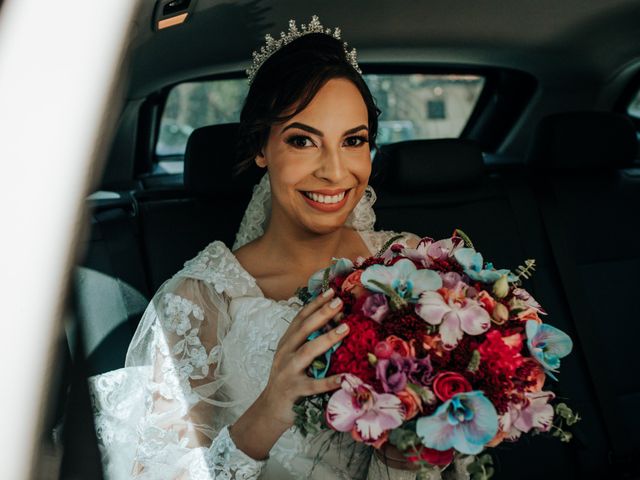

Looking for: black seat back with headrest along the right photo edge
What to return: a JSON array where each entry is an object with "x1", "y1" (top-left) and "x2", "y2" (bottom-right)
[{"x1": 532, "y1": 112, "x2": 640, "y2": 468}]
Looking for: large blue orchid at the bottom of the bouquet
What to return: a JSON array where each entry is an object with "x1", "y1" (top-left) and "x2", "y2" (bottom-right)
[{"x1": 416, "y1": 391, "x2": 498, "y2": 455}]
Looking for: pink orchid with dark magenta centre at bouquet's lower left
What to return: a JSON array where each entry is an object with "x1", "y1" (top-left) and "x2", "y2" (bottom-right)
[{"x1": 326, "y1": 373, "x2": 405, "y2": 444}]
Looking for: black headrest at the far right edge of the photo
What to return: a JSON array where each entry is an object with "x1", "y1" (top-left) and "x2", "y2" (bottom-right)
[{"x1": 527, "y1": 111, "x2": 638, "y2": 170}]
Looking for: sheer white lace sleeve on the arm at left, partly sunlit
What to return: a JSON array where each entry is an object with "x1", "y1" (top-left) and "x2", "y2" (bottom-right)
[{"x1": 92, "y1": 249, "x2": 265, "y2": 480}]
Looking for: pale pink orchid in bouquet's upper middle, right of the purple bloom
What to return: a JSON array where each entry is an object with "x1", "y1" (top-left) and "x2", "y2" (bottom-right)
[{"x1": 416, "y1": 288, "x2": 491, "y2": 350}]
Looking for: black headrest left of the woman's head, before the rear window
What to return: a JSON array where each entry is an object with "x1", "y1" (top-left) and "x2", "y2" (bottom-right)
[{"x1": 184, "y1": 123, "x2": 264, "y2": 196}]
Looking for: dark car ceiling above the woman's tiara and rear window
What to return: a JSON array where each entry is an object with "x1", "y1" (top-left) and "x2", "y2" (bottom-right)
[{"x1": 128, "y1": 0, "x2": 640, "y2": 99}]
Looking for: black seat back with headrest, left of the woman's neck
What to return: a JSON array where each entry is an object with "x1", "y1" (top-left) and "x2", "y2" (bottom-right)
[{"x1": 136, "y1": 124, "x2": 264, "y2": 290}]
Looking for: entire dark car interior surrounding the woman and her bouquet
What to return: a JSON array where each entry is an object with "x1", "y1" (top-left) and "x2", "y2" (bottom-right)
[{"x1": 43, "y1": 0, "x2": 640, "y2": 479}]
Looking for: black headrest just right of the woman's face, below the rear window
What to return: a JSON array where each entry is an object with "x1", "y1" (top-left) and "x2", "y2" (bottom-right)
[{"x1": 376, "y1": 138, "x2": 484, "y2": 192}]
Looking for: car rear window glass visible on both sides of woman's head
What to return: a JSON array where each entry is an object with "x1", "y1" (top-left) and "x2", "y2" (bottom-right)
[{"x1": 156, "y1": 74, "x2": 484, "y2": 160}]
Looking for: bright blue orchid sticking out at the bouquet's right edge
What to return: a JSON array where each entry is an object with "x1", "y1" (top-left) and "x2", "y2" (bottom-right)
[{"x1": 526, "y1": 320, "x2": 573, "y2": 381}]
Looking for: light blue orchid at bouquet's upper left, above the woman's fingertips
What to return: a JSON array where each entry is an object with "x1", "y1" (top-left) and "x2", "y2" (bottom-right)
[{"x1": 360, "y1": 258, "x2": 442, "y2": 301}]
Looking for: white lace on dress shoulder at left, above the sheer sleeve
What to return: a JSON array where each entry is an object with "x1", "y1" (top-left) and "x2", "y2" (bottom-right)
[{"x1": 178, "y1": 240, "x2": 256, "y2": 297}]
